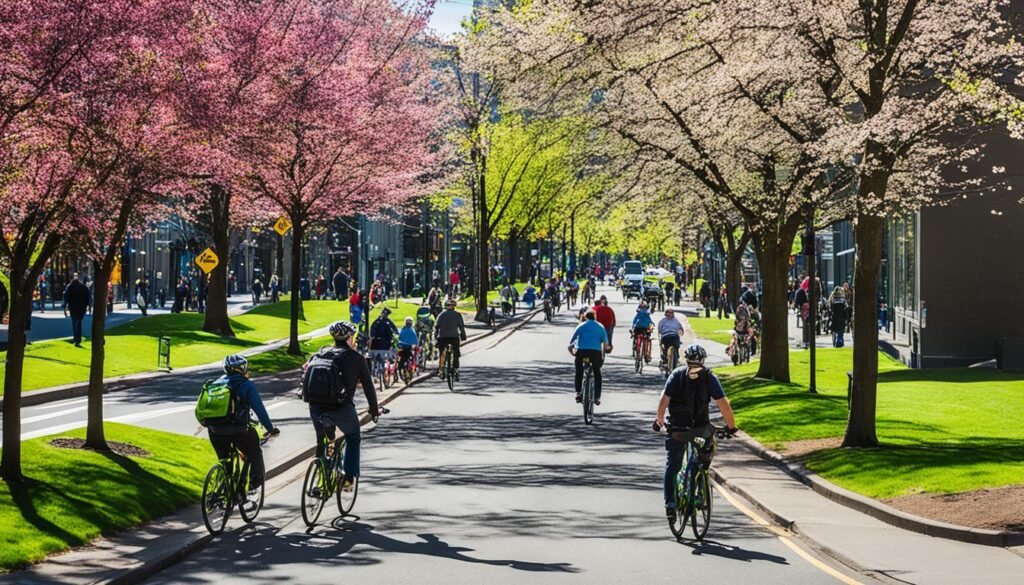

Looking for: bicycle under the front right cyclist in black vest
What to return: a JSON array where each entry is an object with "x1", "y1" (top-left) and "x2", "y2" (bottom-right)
[{"x1": 654, "y1": 422, "x2": 732, "y2": 541}]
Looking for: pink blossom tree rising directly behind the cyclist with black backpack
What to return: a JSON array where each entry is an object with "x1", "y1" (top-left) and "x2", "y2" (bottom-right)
[{"x1": 239, "y1": 0, "x2": 442, "y2": 354}]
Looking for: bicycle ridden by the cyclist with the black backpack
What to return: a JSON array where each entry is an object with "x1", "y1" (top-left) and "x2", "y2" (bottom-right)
[{"x1": 301, "y1": 408, "x2": 391, "y2": 528}]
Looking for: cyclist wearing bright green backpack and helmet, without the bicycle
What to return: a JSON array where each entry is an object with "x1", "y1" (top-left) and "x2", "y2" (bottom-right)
[{"x1": 196, "y1": 354, "x2": 281, "y2": 491}]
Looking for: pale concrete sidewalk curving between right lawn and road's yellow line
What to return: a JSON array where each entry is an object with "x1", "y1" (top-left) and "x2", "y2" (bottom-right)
[{"x1": 713, "y1": 430, "x2": 1024, "y2": 585}]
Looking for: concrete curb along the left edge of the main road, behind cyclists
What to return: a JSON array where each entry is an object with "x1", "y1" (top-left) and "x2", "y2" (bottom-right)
[{"x1": 51, "y1": 309, "x2": 540, "y2": 585}]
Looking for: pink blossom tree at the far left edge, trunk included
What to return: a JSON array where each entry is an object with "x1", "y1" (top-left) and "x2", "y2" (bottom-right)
[{"x1": 0, "y1": 0, "x2": 190, "y2": 482}]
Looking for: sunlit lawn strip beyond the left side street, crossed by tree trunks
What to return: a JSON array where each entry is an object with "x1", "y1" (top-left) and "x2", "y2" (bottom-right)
[{"x1": 0, "y1": 300, "x2": 417, "y2": 390}]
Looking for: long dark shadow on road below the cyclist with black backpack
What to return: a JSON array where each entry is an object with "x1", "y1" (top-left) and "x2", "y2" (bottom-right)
[{"x1": 284, "y1": 517, "x2": 580, "y2": 573}]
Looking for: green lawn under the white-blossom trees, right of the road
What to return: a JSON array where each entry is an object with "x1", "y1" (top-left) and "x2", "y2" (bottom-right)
[{"x1": 716, "y1": 348, "x2": 1024, "y2": 498}]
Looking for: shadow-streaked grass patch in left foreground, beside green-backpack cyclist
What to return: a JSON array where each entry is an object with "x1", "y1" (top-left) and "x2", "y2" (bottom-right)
[{"x1": 0, "y1": 423, "x2": 216, "y2": 571}]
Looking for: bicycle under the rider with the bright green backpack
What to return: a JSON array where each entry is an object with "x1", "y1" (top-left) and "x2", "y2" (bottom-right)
[{"x1": 202, "y1": 426, "x2": 271, "y2": 535}]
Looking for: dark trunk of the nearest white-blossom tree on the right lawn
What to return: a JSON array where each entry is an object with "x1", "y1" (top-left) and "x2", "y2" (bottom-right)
[{"x1": 843, "y1": 212, "x2": 886, "y2": 447}]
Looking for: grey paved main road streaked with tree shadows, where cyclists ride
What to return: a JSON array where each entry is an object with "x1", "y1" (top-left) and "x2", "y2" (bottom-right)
[{"x1": 140, "y1": 293, "x2": 864, "y2": 584}]
